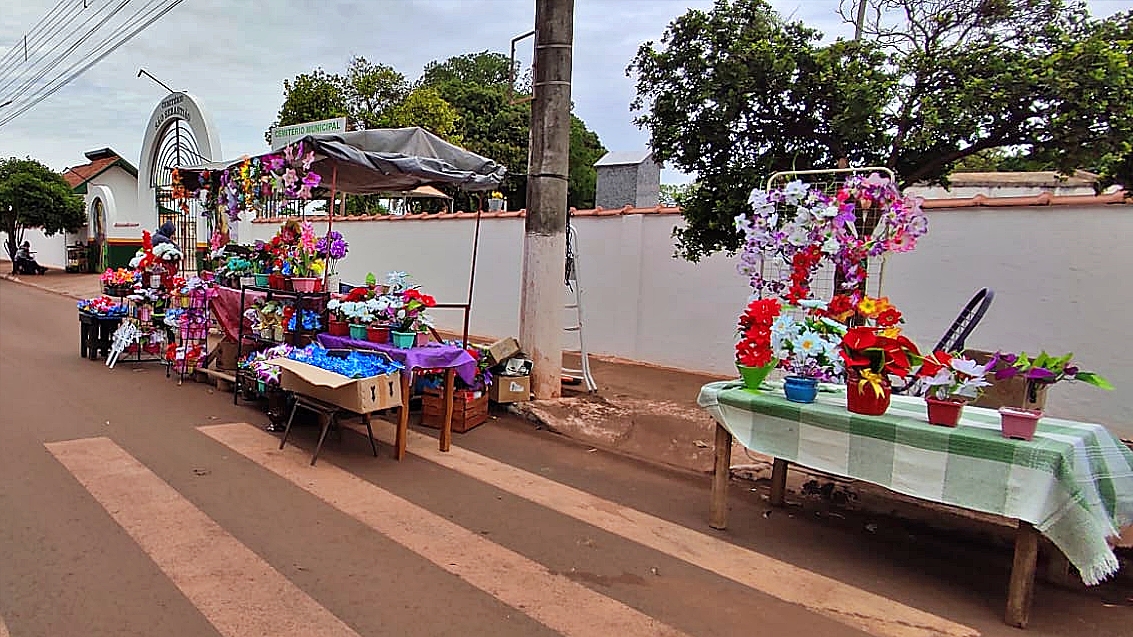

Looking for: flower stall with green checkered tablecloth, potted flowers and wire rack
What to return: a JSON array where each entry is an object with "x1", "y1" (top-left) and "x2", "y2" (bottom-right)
[{"x1": 698, "y1": 171, "x2": 1133, "y2": 628}]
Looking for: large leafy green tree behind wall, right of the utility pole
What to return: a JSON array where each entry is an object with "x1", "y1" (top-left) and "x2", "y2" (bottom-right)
[{"x1": 628, "y1": 0, "x2": 1133, "y2": 261}]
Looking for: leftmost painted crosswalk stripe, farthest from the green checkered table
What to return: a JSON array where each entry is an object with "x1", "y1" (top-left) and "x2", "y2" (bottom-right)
[{"x1": 45, "y1": 438, "x2": 359, "y2": 637}]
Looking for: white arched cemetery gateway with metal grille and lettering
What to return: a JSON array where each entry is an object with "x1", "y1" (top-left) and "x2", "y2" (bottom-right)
[{"x1": 138, "y1": 92, "x2": 221, "y2": 271}]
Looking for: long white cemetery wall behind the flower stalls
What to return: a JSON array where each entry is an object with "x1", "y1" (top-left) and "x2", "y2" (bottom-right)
[{"x1": 241, "y1": 205, "x2": 1133, "y2": 436}]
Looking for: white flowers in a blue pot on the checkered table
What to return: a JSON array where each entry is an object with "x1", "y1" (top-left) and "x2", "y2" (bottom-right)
[{"x1": 770, "y1": 314, "x2": 844, "y2": 402}]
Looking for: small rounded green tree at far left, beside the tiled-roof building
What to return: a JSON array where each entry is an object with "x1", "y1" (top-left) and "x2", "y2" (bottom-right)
[{"x1": 0, "y1": 158, "x2": 86, "y2": 261}]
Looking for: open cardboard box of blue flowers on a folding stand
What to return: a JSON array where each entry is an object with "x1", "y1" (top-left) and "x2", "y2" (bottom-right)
[{"x1": 270, "y1": 358, "x2": 401, "y2": 414}]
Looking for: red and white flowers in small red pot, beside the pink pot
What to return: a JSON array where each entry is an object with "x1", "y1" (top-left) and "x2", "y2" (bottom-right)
[{"x1": 913, "y1": 351, "x2": 991, "y2": 427}]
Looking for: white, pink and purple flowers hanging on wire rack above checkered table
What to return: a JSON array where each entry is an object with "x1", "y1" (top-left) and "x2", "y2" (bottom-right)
[{"x1": 735, "y1": 173, "x2": 928, "y2": 304}]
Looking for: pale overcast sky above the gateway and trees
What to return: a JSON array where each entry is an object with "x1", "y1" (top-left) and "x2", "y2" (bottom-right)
[{"x1": 0, "y1": 0, "x2": 1133, "y2": 181}]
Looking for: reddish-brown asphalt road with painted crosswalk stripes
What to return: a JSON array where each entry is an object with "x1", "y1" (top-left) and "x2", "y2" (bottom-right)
[{"x1": 0, "y1": 281, "x2": 1133, "y2": 637}]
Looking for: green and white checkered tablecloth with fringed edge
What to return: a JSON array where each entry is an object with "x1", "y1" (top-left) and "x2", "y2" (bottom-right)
[{"x1": 698, "y1": 381, "x2": 1133, "y2": 585}]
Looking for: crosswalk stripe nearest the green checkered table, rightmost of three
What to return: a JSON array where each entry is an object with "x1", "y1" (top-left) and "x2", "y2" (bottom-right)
[{"x1": 335, "y1": 419, "x2": 979, "y2": 637}]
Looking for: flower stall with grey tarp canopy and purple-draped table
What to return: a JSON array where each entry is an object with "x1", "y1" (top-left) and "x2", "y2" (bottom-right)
[{"x1": 176, "y1": 128, "x2": 505, "y2": 459}]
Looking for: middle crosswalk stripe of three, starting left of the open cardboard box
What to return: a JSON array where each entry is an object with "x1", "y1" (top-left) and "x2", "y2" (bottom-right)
[{"x1": 198, "y1": 423, "x2": 684, "y2": 637}]
